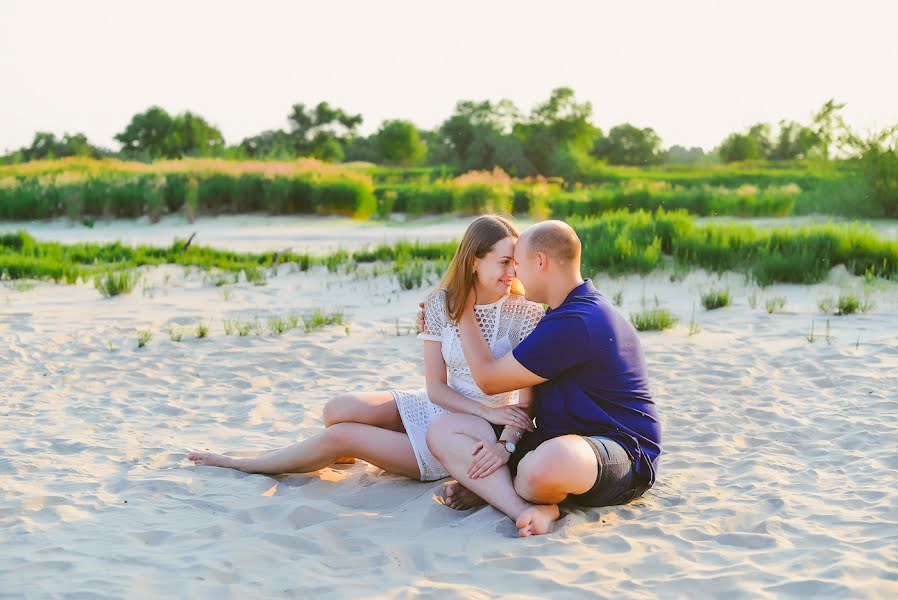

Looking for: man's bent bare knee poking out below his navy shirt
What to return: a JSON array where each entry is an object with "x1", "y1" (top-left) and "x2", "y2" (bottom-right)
[{"x1": 514, "y1": 435, "x2": 599, "y2": 504}]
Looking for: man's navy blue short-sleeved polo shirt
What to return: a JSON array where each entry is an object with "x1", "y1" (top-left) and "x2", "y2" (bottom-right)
[{"x1": 514, "y1": 279, "x2": 661, "y2": 484}]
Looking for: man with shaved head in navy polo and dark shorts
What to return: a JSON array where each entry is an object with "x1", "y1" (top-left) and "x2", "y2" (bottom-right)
[{"x1": 420, "y1": 221, "x2": 661, "y2": 536}]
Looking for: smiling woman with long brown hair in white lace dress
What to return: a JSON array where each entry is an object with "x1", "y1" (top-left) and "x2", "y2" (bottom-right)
[{"x1": 187, "y1": 215, "x2": 543, "y2": 481}]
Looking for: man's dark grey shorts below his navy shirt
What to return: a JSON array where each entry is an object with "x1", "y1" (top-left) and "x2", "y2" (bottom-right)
[{"x1": 493, "y1": 425, "x2": 651, "y2": 506}]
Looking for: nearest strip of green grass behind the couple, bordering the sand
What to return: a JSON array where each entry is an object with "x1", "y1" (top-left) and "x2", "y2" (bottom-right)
[{"x1": 0, "y1": 209, "x2": 898, "y2": 290}]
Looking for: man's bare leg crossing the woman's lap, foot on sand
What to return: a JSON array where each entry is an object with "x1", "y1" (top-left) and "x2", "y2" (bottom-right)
[{"x1": 427, "y1": 413, "x2": 559, "y2": 536}]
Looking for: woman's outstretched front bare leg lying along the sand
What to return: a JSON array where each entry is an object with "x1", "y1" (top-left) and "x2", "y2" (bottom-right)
[{"x1": 187, "y1": 423, "x2": 421, "y2": 479}]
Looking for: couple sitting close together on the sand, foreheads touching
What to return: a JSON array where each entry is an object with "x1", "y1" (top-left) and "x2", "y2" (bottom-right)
[{"x1": 188, "y1": 215, "x2": 661, "y2": 536}]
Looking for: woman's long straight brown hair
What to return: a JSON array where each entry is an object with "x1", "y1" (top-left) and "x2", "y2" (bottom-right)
[{"x1": 440, "y1": 215, "x2": 524, "y2": 321}]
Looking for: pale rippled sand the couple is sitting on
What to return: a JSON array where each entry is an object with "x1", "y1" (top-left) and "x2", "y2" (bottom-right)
[{"x1": 0, "y1": 221, "x2": 898, "y2": 599}]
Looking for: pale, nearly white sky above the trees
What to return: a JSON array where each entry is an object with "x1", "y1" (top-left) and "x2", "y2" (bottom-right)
[{"x1": 0, "y1": 0, "x2": 898, "y2": 152}]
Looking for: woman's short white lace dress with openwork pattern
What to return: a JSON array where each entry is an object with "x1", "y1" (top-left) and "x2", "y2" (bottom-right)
[{"x1": 390, "y1": 290, "x2": 544, "y2": 481}]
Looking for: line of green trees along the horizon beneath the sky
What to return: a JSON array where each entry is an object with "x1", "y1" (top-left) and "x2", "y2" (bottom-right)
[{"x1": 0, "y1": 87, "x2": 894, "y2": 180}]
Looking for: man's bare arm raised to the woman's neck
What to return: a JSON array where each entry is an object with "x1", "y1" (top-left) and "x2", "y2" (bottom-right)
[{"x1": 458, "y1": 294, "x2": 548, "y2": 395}]
